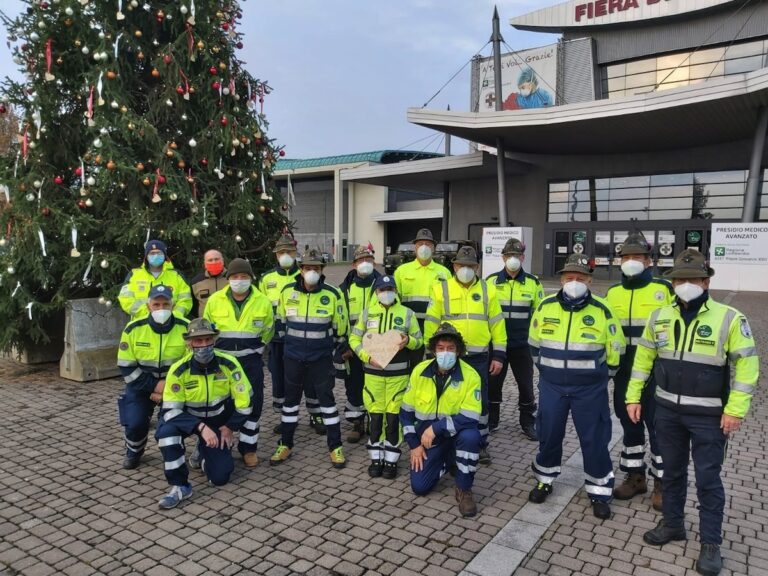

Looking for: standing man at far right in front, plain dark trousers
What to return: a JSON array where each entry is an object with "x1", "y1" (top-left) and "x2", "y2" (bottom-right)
[{"x1": 627, "y1": 249, "x2": 760, "y2": 575}]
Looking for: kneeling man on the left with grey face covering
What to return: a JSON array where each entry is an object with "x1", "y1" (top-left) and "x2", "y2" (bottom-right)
[{"x1": 155, "y1": 318, "x2": 252, "y2": 510}]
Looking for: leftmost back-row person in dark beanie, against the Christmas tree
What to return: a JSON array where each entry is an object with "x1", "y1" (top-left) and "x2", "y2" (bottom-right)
[{"x1": 117, "y1": 240, "x2": 192, "y2": 320}]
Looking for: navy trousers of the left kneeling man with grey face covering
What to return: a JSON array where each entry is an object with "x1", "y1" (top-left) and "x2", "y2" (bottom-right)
[{"x1": 155, "y1": 414, "x2": 235, "y2": 486}]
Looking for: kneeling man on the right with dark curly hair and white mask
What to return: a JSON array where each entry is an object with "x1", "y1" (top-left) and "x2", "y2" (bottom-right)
[{"x1": 400, "y1": 323, "x2": 481, "y2": 517}]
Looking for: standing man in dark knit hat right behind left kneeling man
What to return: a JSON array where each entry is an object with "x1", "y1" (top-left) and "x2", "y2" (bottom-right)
[{"x1": 203, "y1": 258, "x2": 275, "y2": 468}]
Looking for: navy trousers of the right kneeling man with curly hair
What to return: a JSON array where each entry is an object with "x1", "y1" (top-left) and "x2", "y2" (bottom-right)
[{"x1": 411, "y1": 428, "x2": 481, "y2": 496}]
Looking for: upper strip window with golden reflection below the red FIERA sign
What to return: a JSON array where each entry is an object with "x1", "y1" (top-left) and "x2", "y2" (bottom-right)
[{"x1": 600, "y1": 40, "x2": 768, "y2": 98}]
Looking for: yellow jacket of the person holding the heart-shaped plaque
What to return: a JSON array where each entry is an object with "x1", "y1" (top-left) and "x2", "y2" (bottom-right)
[{"x1": 349, "y1": 300, "x2": 423, "y2": 378}]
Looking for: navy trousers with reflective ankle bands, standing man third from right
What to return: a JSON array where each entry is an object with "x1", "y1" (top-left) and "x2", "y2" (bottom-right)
[{"x1": 533, "y1": 379, "x2": 614, "y2": 502}]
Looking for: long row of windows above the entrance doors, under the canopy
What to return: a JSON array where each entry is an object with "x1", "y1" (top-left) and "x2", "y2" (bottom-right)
[{"x1": 548, "y1": 170, "x2": 752, "y2": 222}]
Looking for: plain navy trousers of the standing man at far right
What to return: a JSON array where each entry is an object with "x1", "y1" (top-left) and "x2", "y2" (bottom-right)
[{"x1": 656, "y1": 405, "x2": 727, "y2": 546}]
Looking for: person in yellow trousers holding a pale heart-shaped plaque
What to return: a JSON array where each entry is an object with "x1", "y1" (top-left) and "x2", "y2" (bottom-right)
[{"x1": 349, "y1": 276, "x2": 422, "y2": 480}]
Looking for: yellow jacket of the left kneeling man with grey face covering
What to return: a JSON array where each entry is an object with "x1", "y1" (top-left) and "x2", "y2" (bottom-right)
[{"x1": 160, "y1": 350, "x2": 252, "y2": 430}]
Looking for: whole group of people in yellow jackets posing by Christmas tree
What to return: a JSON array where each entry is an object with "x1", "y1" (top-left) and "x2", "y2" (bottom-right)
[{"x1": 118, "y1": 229, "x2": 758, "y2": 574}]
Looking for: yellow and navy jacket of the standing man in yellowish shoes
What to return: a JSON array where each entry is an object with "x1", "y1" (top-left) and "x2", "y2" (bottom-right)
[{"x1": 277, "y1": 276, "x2": 349, "y2": 362}]
